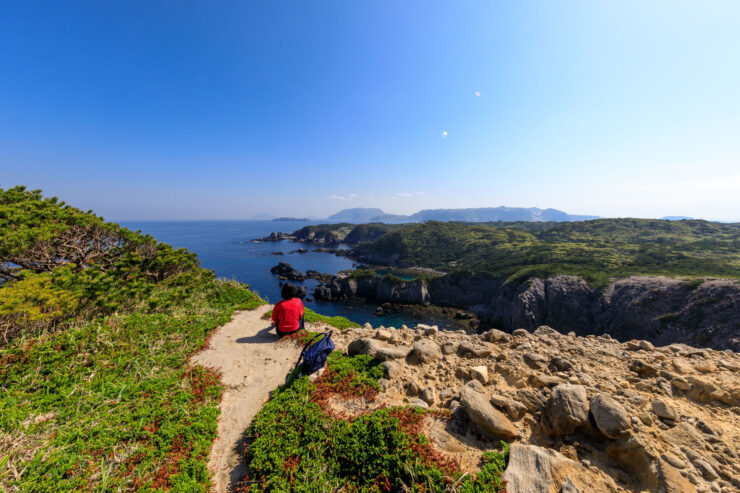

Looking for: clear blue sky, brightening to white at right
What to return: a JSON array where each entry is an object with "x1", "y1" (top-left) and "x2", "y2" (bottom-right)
[{"x1": 0, "y1": 0, "x2": 740, "y2": 220}]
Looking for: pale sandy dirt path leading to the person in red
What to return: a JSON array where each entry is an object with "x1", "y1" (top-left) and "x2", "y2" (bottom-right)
[{"x1": 192, "y1": 305, "x2": 300, "y2": 493}]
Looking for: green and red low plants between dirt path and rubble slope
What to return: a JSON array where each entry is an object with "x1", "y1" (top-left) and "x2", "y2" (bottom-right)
[{"x1": 238, "y1": 353, "x2": 507, "y2": 492}]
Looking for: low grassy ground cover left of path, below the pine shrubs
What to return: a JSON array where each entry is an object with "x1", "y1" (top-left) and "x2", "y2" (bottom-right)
[{"x1": 0, "y1": 281, "x2": 264, "y2": 492}]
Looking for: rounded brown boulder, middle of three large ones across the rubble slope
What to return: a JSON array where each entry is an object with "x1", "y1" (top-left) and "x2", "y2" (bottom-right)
[{"x1": 543, "y1": 383, "x2": 589, "y2": 436}]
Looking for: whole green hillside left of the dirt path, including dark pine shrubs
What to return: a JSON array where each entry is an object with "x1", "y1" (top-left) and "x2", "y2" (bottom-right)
[{"x1": 0, "y1": 187, "x2": 264, "y2": 492}]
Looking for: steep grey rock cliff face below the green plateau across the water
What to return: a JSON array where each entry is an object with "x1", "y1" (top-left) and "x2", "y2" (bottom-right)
[{"x1": 315, "y1": 274, "x2": 740, "y2": 351}]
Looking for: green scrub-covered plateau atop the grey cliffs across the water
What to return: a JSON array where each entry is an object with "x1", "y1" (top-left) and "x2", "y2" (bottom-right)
[{"x1": 355, "y1": 219, "x2": 740, "y2": 285}]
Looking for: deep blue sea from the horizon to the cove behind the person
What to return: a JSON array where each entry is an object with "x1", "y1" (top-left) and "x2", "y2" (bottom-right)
[{"x1": 120, "y1": 221, "x2": 456, "y2": 327}]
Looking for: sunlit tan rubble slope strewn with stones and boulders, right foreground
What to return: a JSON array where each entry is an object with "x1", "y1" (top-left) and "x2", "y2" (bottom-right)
[{"x1": 332, "y1": 324, "x2": 740, "y2": 493}]
